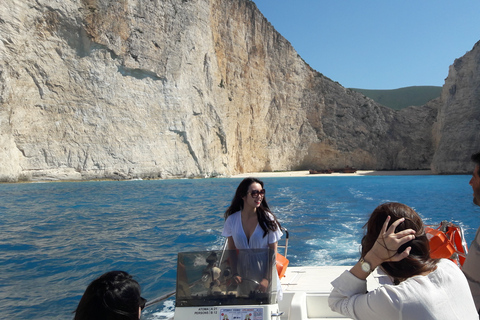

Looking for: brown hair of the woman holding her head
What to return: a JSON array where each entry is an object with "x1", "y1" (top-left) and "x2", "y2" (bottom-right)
[{"x1": 362, "y1": 202, "x2": 438, "y2": 284}]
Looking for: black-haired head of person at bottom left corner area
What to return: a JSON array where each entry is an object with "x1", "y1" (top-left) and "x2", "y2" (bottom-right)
[{"x1": 74, "y1": 271, "x2": 147, "y2": 320}]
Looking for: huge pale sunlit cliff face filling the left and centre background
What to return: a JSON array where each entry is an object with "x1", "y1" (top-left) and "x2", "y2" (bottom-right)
[{"x1": 0, "y1": 0, "x2": 472, "y2": 181}]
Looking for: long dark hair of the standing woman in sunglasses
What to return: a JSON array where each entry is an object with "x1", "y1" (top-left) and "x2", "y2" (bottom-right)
[{"x1": 225, "y1": 178, "x2": 281, "y2": 237}]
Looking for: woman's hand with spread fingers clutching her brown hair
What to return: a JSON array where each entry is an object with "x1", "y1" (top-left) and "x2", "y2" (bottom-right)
[{"x1": 365, "y1": 216, "x2": 415, "y2": 269}]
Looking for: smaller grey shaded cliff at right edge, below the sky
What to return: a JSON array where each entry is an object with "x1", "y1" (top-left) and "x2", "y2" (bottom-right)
[{"x1": 432, "y1": 42, "x2": 480, "y2": 173}]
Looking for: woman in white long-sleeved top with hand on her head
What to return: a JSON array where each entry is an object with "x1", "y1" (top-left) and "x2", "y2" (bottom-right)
[{"x1": 328, "y1": 203, "x2": 478, "y2": 320}]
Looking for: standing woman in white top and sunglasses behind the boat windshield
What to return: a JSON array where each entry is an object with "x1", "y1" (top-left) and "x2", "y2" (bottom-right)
[{"x1": 222, "y1": 178, "x2": 283, "y2": 294}]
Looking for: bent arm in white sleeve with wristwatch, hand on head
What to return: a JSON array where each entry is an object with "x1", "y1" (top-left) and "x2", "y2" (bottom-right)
[{"x1": 328, "y1": 217, "x2": 415, "y2": 319}]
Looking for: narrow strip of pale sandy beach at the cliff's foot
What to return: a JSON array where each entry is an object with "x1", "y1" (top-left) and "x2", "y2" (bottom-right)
[{"x1": 232, "y1": 170, "x2": 433, "y2": 178}]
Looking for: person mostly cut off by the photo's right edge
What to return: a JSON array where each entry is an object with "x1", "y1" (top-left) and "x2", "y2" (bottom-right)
[{"x1": 462, "y1": 152, "x2": 480, "y2": 314}]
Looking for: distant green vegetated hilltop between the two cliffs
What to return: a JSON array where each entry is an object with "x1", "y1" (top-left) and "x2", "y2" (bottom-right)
[{"x1": 350, "y1": 86, "x2": 442, "y2": 110}]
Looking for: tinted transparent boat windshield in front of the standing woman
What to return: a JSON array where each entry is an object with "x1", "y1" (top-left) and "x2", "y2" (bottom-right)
[{"x1": 176, "y1": 249, "x2": 278, "y2": 307}]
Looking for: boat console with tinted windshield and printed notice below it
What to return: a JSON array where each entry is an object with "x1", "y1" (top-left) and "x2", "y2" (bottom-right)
[{"x1": 175, "y1": 249, "x2": 280, "y2": 320}]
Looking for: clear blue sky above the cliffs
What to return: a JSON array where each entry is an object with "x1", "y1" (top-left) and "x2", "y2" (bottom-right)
[{"x1": 253, "y1": 0, "x2": 480, "y2": 89}]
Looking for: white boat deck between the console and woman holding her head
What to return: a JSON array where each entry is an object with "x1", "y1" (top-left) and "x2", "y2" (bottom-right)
[{"x1": 279, "y1": 266, "x2": 388, "y2": 320}]
